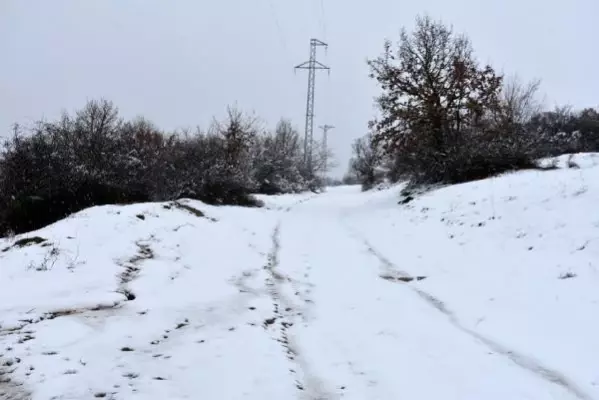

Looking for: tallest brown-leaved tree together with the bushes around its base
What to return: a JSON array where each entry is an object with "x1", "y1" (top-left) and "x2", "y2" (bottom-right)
[{"x1": 369, "y1": 17, "x2": 552, "y2": 183}]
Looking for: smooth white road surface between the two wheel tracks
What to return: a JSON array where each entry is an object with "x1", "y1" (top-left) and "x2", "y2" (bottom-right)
[{"x1": 266, "y1": 190, "x2": 590, "y2": 400}]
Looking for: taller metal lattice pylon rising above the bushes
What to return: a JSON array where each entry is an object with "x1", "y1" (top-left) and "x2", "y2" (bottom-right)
[{"x1": 295, "y1": 39, "x2": 330, "y2": 173}]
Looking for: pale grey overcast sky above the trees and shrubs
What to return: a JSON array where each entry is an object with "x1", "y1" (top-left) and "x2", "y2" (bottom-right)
[{"x1": 0, "y1": 0, "x2": 599, "y2": 175}]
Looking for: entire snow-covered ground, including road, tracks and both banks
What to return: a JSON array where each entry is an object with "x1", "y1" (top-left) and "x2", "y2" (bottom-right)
[{"x1": 0, "y1": 155, "x2": 599, "y2": 400}]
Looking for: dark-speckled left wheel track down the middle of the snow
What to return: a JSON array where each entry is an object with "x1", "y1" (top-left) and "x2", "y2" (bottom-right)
[{"x1": 264, "y1": 222, "x2": 338, "y2": 400}]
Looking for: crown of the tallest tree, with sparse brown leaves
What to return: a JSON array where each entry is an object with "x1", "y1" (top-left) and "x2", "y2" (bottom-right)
[{"x1": 368, "y1": 16, "x2": 501, "y2": 154}]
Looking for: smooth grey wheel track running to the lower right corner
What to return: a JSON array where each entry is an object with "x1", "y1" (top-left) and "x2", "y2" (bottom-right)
[{"x1": 343, "y1": 223, "x2": 593, "y2": 400}]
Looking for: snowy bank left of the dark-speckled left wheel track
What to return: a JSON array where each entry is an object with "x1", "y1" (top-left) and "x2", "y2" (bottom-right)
[{"x1": 0, "y1": 195, "x2": 314, "y2": 399}]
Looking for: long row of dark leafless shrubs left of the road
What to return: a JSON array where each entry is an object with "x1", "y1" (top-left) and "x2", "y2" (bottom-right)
[{"x1": 0, "y1": 100, "x2": 306, "y2": 235}]
